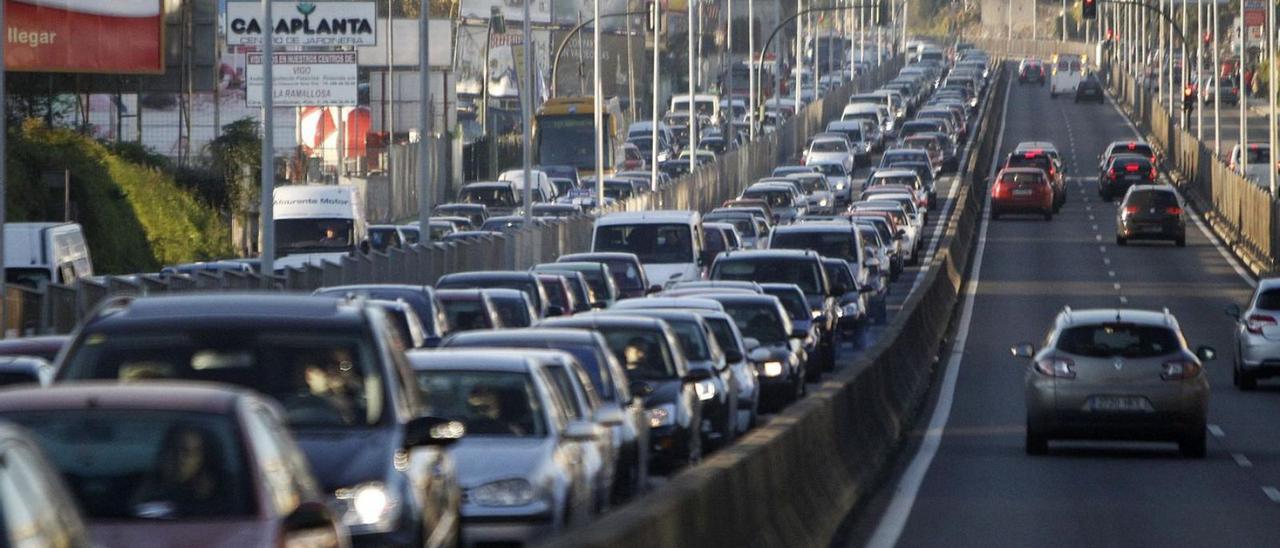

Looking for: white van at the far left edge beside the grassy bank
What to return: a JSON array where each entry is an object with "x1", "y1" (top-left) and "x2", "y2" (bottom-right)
[{"x1": 4, "y1": 223, "x2": 93, "y2": 288}]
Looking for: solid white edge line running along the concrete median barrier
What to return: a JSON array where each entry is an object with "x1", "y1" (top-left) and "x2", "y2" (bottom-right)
[{"x1": 867, "y1": 74, "x2": 1014, "y2": 548}]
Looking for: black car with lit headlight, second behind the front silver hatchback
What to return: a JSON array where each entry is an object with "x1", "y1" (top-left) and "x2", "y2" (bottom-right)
[{"x1": 538, "y1": 312, "x2": 710, "y2": 471}]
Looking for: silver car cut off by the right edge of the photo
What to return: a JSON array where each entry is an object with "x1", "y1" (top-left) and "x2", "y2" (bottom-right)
[{"x1": 1226, "y1": 278, "x2": 1280, "y2": 391}]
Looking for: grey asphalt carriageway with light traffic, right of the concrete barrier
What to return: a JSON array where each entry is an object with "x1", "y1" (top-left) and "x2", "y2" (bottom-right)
[{"x1": 836, "y1": 67, "x2": 1280, "y2": 547}]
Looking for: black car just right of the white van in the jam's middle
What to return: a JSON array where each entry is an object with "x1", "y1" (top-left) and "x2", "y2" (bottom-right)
[{"x1": 708, "y1": 249, "x2": 834, "y2": 371}]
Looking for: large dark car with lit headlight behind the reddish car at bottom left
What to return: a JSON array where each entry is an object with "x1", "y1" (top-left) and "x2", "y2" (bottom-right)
[{"x1": 56, "y1": 293, "x2": 461, "y2": 545}]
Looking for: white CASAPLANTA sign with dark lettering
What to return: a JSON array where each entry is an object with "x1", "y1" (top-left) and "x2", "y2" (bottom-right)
[{"x1": 225, "y1": 1, "x2": 378, "y2": 46}]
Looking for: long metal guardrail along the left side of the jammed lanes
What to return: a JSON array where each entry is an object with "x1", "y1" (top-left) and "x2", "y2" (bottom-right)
[{"x1": 5, "y1": 63, "x2": 900, "y2": 335}]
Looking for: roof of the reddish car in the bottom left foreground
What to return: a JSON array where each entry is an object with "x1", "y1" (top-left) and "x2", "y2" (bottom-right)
[{"x1": 0, "y1": 380, "x2": 245, "y2": 414}]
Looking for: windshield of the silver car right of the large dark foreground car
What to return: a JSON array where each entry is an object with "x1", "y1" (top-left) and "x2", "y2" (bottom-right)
[{"x1": 417, "y1": 371, "x2": 547, "y2": 438}]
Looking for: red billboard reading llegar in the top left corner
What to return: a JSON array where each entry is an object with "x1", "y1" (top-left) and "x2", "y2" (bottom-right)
[{"x1": 3, "y1": 0, "x2": 164, "y2": 74}]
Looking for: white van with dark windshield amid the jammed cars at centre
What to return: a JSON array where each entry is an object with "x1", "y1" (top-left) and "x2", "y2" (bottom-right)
[{"x1": 591, "y1": 210, "x2": 710, "y2": 287}]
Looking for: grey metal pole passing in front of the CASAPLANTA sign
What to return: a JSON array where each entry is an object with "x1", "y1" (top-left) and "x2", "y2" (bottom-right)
[{"x1": 256, "y1": 0, "x2": 275, "y2": 284}]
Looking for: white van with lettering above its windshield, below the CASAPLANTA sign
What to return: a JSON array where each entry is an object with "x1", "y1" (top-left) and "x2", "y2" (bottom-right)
[{"x1": 273, "y1": 184, "x2": 369, "y2": 270}]
